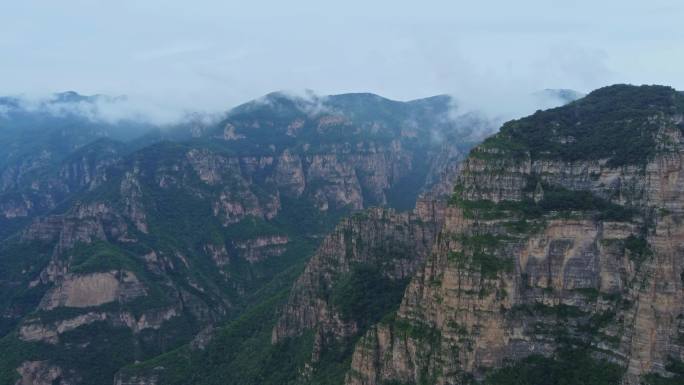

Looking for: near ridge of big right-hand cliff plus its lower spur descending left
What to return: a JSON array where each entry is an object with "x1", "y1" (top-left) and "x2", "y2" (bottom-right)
[{"x1": 108, "y1": 86, "x2": 684, "y2": 385}]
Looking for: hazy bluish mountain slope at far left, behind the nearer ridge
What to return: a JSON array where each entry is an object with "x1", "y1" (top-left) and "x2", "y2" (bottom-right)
[{"x1": 0, "y1": 92, "x2": 164, "y2": 239}]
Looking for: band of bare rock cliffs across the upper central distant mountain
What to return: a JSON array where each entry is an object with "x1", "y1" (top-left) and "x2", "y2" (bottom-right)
[{"x1": 174, "y1": 141, "x2": 448, "y2": 225}]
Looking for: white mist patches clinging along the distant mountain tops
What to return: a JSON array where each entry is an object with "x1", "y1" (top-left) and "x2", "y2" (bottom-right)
[{"x1": 0, "y1": 89, "x2": 582, "y2": 135}]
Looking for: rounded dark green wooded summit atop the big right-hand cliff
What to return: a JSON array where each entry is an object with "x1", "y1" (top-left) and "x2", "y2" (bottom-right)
[{"x1": 484, "y1": 84, "x2": 684, "y2": 166}]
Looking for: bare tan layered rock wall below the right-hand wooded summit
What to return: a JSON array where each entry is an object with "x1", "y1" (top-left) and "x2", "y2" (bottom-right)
[{"x1": 346, "y1": 128, "x2": 684, "y2": 385}]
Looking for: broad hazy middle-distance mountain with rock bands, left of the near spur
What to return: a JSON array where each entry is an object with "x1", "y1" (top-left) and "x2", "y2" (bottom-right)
[{"x1": 0, "y1": 88, "x2": 480, "y2": 384}]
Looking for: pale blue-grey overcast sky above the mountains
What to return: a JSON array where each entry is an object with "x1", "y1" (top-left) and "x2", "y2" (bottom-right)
[{"x1": 0, "y1": 0, "x2": 684, "y2": 120}]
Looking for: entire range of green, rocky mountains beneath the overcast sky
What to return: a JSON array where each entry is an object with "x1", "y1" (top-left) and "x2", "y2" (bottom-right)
[{"x1": 5, "y1": 85, "x2": 684, "y2": 385}]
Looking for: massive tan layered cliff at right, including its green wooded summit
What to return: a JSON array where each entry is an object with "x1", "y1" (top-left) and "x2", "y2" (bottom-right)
[{"x1": 346, "y1": 86, "x2": 684, "y2": 385}]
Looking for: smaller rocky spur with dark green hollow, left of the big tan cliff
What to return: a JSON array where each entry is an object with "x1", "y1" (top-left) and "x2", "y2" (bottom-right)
[{"x1": 271, "y1": 199, "x2": 445, "y2": 384}]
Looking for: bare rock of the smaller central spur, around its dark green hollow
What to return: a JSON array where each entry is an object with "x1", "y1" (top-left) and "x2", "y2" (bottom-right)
[{"x1": 272, "y1": 200, "x2": 445, "y2": 363}]
